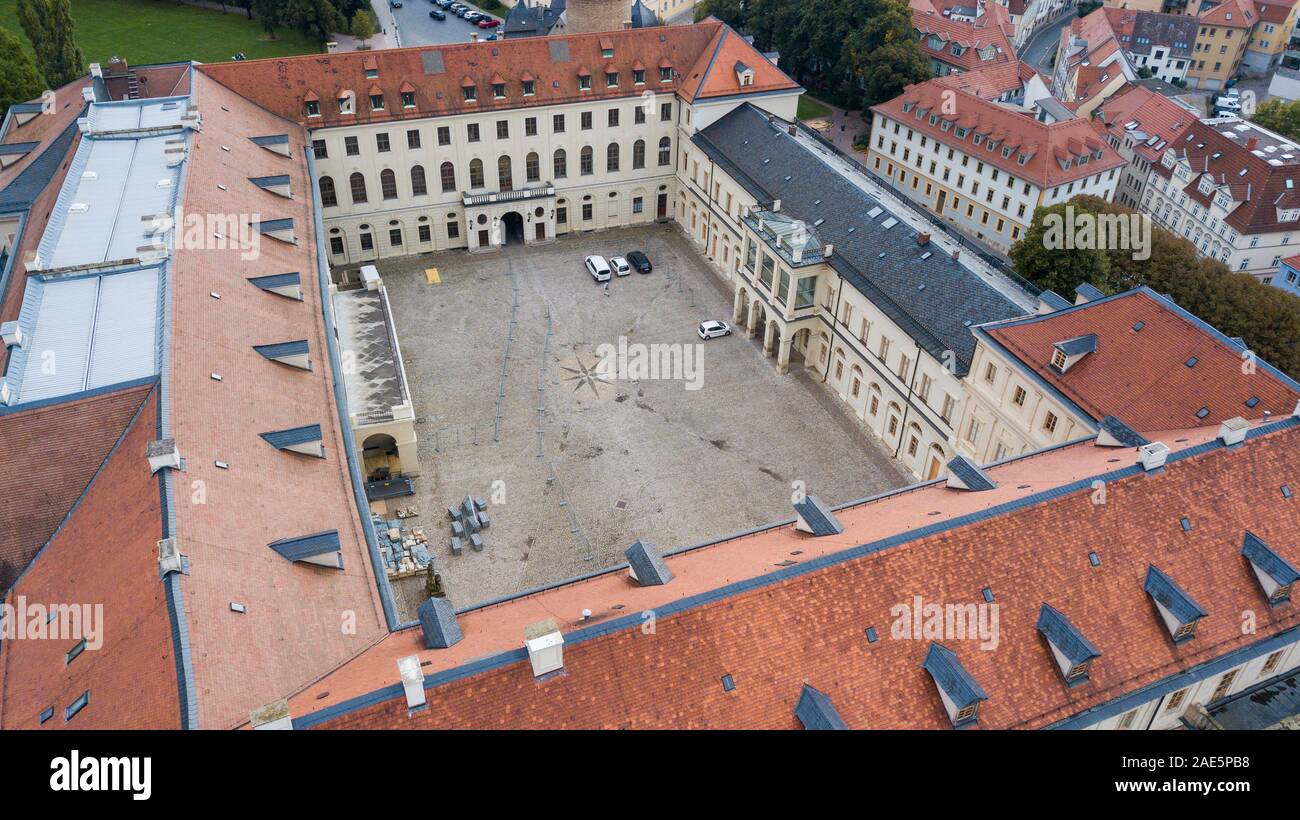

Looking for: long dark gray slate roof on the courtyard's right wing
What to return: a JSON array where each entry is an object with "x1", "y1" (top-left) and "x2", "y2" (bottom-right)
[{"x1": 692, "y1": 103, "x2": 1026, "y2": 376}]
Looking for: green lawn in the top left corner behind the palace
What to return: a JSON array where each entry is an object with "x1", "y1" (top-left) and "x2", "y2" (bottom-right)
[{"x1": 0, "y1": 0, "x2": 321, "y2": 65}]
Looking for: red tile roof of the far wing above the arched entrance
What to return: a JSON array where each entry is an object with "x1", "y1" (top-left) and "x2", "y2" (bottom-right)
[{"x1": 198, "y1": 18, "x2": 798, "y2": 127}]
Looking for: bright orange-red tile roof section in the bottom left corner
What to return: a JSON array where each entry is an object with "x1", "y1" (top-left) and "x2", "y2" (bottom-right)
[{"x1": 0, "y1": 390, "x2": 181, "y2": 729}]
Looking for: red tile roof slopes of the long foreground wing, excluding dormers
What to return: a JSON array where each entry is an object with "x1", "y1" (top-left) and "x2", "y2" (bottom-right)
[{"x1": 291, "y1": 420, "x2": 1300, "y2": 729}]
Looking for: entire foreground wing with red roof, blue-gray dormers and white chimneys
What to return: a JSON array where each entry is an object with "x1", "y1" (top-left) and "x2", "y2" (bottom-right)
[{"x1": 289, "y1": 417, "x2": 1300, "y2": 730}]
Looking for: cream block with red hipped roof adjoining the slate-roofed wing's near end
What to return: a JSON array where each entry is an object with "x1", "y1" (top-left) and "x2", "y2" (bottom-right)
[{"x1": 957, "y1": 287, "x2": 1300, "y2": 464}]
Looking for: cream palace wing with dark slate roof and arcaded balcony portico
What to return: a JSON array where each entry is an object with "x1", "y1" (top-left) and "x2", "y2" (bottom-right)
[{"x1": 677, "y1": 105, "x2": 1036, "y2": 478}]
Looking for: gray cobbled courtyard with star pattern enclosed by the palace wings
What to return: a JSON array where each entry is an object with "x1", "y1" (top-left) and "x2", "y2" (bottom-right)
[{"x1": 377, "y1": 225, "x2": 909, "y2": 617}]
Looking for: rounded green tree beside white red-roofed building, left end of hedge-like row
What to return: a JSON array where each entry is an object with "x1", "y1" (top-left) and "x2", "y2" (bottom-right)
[{"x1": 1008, "y1": 200, "x2": 1110, "y2": 295}]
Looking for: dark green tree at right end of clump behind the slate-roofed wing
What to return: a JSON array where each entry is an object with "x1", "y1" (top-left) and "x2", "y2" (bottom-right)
[{"x1": 848, "y1": 0, "x2": 933, "y2": 110}]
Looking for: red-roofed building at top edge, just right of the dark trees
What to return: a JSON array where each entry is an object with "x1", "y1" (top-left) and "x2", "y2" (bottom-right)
[{"x1": 911, "y1": 0, "x2": 1015, "y2": 77}]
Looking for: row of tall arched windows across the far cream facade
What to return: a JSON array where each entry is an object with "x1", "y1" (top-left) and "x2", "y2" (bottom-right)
[{"x1": 320, "y1": 136, "x2": 672, "y2": 207}]
